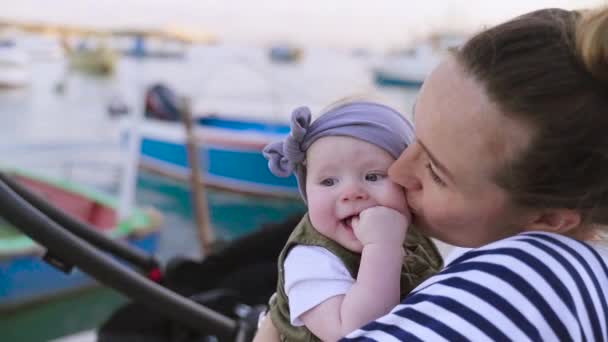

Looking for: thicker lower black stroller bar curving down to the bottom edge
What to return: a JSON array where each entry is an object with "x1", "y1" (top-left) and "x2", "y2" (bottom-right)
[{"x1": 0, "y1": 175, "x2": 253, "y2": 341}]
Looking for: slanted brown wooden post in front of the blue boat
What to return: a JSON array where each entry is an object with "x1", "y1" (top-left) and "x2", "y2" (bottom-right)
[{"x1": 180, "y1": 98, "x2": 214, "y2": 256}]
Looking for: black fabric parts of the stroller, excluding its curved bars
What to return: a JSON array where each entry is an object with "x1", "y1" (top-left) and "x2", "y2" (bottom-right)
[{"x1": 98, "y1": 216, "x2": 301, "y2": 342}]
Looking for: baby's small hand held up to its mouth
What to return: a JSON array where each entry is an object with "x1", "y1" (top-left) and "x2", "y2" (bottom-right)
[{"x1": 352, "y1": 206, "x2": 410, "y2": 246}]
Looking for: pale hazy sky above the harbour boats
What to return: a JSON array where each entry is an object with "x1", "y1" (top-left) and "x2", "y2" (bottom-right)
[{"x1": 0, "y1": 0, "x2": 608, "y2": 48}]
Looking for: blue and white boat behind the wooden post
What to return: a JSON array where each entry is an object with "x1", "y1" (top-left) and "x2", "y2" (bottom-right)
[{"x1": 133, "y1": 116, "x2": 298, "y2": 197}]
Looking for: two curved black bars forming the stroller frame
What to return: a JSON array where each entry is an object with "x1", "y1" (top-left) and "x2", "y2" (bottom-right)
[{"x1": 0, "y1": 172, "x2": 257, "y2": 342}]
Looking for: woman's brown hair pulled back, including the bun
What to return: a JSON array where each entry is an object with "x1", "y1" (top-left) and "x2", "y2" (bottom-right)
[{"x1": 454, "y1": 8, "x2": 608, "y2": 224}]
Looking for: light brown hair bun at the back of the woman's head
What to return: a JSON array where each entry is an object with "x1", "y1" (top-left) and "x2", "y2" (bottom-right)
[{"x1": 576, "y1": 7, "x2": 608, "y2": 82}]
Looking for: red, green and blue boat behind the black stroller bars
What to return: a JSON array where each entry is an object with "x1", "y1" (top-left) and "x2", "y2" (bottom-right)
[{"x1": 0, "y1": 169, "x2": 161, "y2": 312}]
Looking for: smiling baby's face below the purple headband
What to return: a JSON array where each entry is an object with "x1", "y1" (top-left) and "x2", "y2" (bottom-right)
[{"x1": 306, "y1": 136, "x2": 407, "y2": 252}]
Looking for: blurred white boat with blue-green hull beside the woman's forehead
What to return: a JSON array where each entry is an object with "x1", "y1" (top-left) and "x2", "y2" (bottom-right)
[{"x1": 374, "y1": 36, "x2": 463, "y2": 87}]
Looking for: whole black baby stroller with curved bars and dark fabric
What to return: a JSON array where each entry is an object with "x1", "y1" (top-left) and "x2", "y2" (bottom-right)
[{"x1": 0, "y1": 173, "x2": 300, "y2": 342}]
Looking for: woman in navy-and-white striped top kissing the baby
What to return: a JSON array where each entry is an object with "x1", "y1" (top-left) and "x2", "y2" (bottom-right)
[{"x1": 257, "y1": 5, "x2": 608, "y2": 341}]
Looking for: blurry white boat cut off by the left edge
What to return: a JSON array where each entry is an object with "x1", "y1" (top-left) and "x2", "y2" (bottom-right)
[{"x1": 0, "y1": 39, "x2": 30, "y2": 88}]
